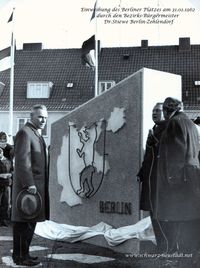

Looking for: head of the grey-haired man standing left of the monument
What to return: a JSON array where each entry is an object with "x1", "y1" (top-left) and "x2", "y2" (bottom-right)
[{"x1": 31, "y1": 109, "x2": 48, "y2": 129}]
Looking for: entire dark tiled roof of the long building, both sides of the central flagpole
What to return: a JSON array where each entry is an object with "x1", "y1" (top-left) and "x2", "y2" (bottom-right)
[{"x1": 0, "y1": 45, "x2": 200, "y2": 111}]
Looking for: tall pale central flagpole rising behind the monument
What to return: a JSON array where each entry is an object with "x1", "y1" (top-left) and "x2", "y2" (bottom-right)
[{"x1": 95, "y1": 1, "x2": 99, "y2": 97}]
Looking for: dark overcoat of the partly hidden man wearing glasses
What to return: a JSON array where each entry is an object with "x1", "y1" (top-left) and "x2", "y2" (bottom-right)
[{"x1": 137, "y1": 121, "x2": 165, "y2": 211}]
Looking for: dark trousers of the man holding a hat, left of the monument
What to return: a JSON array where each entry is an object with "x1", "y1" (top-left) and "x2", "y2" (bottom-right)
[{"x1": 13, "y1": 222, "x2": 36, "y2": 259}]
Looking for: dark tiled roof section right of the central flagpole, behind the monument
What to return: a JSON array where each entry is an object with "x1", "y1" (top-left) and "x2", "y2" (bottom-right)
[{"x1": 99, "y1": 45, "x2": 200, "y2": 109}]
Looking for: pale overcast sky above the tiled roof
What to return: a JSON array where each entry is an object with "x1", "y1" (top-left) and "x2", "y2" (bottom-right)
[{"x1": 0, "y1": 0, "x2": 200, "y2": 48}]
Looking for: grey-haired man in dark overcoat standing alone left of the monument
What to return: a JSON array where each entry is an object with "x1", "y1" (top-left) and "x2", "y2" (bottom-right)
[{"x1": 11, "y1": 105, "x2": 49, "y2": 266}]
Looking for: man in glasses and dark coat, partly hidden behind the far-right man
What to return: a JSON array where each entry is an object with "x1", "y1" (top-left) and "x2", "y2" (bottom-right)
[{"x1": 137, "y1": 103, "x2": 165, "y2": 251}]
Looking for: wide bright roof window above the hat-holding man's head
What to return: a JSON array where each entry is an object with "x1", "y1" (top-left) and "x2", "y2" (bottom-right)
[{"x1": 27, "y1": 82, "x2": 53, "y2": 99}]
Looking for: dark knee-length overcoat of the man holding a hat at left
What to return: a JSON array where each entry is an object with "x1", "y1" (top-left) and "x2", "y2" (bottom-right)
[{"x1": 11, "y1": 123, "x2": 49, "y2": 222}]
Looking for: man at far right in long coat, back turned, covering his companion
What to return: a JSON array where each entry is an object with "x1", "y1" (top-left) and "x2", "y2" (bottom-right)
[{"x1": 154, "y1": 98, "x2": 200, "y2": 253}]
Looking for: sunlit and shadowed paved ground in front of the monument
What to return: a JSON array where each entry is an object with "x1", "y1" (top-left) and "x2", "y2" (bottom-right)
[{"x1": 0, "y1": 226, "x2": 200, "y2": 268}]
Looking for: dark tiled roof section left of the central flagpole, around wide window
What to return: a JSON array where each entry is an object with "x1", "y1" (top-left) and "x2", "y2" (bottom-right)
[{"x1": 0, "y1": 49, "x2": 94, "y2": 111}]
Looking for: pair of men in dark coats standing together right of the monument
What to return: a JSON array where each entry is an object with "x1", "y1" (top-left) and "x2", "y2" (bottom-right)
[{"x1": 137, "y1": 97, "x2": 200, "y2": 254}]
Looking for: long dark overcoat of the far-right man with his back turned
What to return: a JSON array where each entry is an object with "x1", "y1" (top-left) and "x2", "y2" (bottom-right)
[{"x1": 154, "y1": 112, "x2": 200, "y2": 221}]
